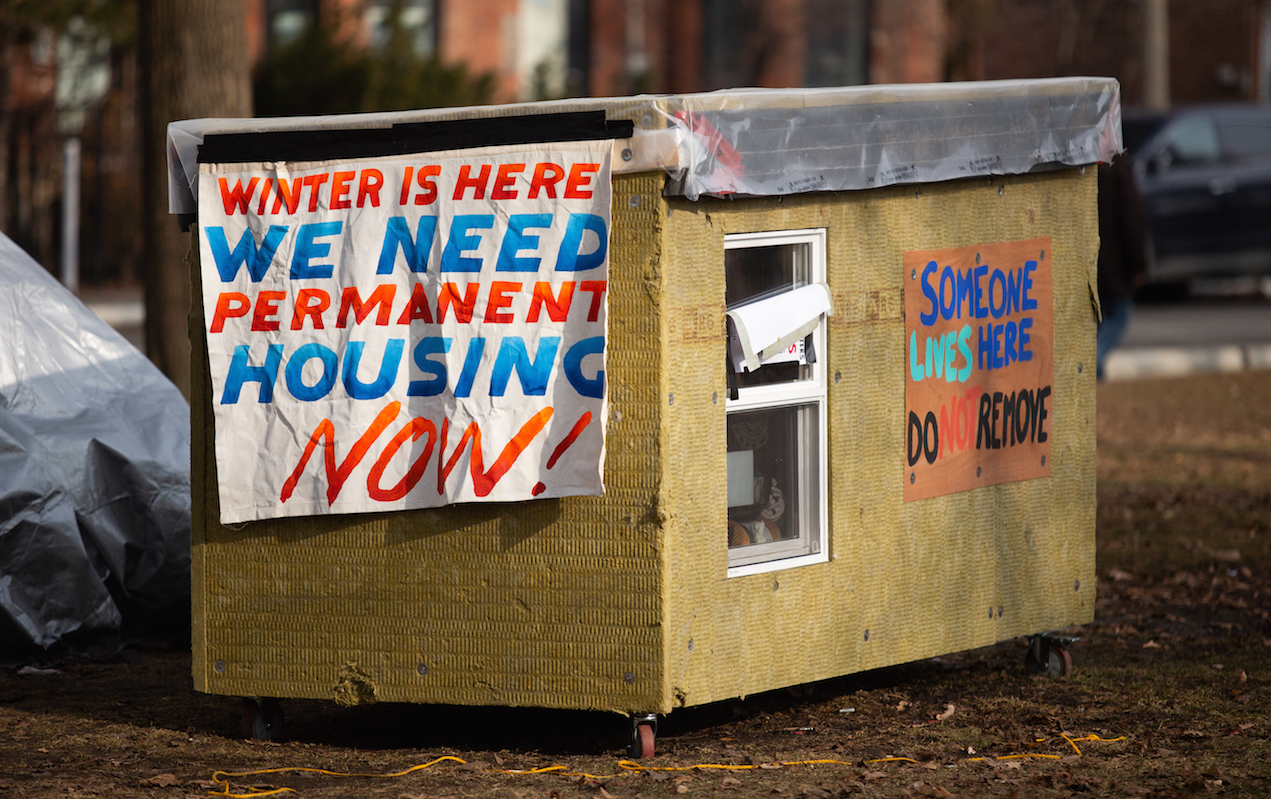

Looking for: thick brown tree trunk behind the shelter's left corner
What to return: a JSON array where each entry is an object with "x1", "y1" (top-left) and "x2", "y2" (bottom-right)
[{"x1": 140, "y1": 0, "x2": 252, "y2": 399}]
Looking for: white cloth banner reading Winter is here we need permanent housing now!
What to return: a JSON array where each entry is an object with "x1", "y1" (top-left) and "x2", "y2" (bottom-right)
[{"x1": 198, "y1": 141, "x2": 610, "y2": 523}]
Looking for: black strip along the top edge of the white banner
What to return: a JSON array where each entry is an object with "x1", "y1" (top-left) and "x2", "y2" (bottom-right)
[{"x1": 198, "y1": 111, "x2": 634, "y2": 164}]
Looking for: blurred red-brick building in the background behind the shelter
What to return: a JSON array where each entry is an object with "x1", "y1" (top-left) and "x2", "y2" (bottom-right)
[{"x1": 0, "y1": 0, "x2": 1271, "y2": 286}]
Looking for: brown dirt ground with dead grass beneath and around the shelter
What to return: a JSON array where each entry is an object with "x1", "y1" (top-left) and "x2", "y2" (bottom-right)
[{"x1": 0, "y1": 372, "x2": 1271, "y2": 799}]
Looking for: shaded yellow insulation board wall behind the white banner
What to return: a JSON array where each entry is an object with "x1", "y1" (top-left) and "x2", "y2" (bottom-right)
[{"x1": 192, "y1": 174, "x2": 667, "y2": 711}]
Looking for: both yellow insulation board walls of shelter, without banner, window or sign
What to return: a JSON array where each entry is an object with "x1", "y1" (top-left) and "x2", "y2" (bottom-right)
[{"x1": 192, "y1": 170, "x2": 1098, "y2": 713}]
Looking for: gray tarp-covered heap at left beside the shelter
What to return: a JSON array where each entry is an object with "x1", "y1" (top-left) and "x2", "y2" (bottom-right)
[{"x1": 0, "y1": 227, "x2": 189, "y2": 661}]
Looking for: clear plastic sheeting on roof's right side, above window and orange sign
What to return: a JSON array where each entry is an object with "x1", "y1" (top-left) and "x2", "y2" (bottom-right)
[{"x1": 650, "y1": 79, "x2": 1121, "y2": 199}]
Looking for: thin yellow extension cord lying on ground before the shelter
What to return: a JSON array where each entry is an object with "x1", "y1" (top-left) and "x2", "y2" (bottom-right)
[{"x1": 208, "y1": 733, "x2": 1125, "y2": 799}]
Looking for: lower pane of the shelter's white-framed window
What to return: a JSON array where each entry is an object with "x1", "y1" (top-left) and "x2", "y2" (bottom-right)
[{"x1": 727, "y1": 403, "x2": 819, "y2": 556}]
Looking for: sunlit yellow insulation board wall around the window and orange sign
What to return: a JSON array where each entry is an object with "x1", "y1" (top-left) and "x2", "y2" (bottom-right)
[{"x1": 662, "y1": 168, "x2": 1098, "y2": 705}]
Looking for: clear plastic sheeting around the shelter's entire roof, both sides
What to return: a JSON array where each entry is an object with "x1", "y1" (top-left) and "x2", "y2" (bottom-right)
[{"x1": 168, "y1": 77, "x2": 1122, "y2": 213}]
